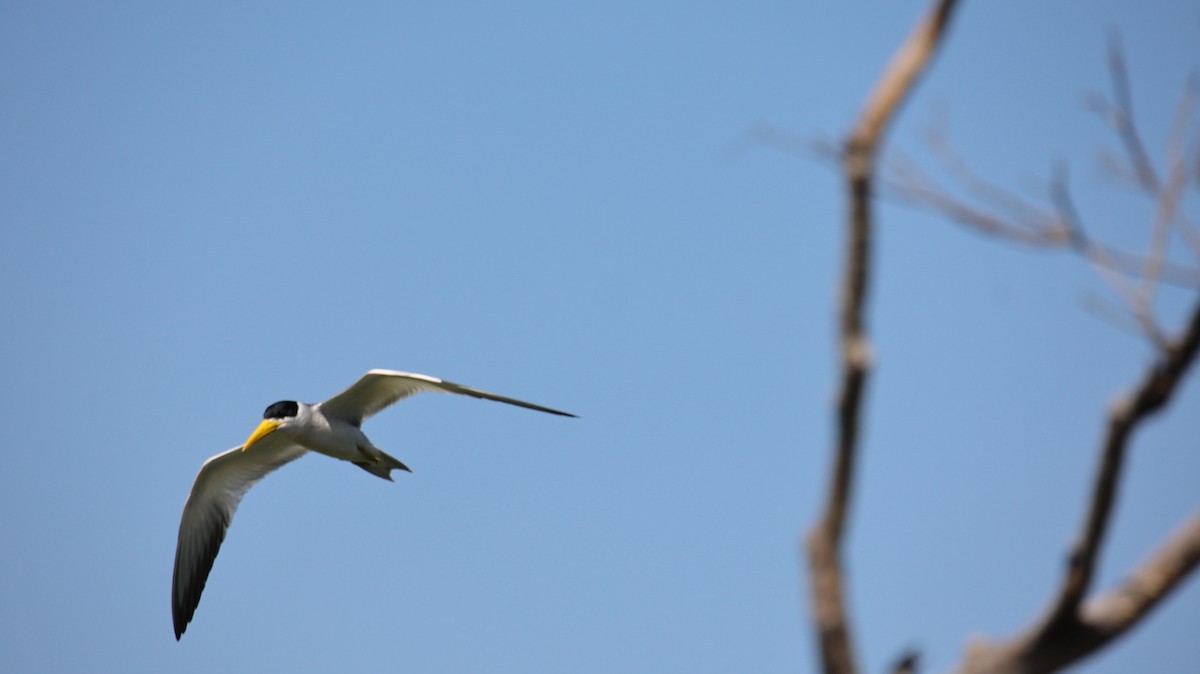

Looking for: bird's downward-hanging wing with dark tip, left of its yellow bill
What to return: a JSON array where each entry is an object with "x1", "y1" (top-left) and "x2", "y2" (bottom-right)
[{"x1": 170, "y1": 434, "x2": 306, "y2": 640}]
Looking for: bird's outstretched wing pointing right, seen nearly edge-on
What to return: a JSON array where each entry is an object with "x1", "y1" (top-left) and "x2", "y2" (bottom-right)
[{"x1": 320, "y1": 369, "x2": 575, "y2": 426}]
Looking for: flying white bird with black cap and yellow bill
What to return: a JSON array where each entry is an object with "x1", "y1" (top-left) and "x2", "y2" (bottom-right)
[{"x1": 170, "y1": 369, "x2": 575, "y2": 640}]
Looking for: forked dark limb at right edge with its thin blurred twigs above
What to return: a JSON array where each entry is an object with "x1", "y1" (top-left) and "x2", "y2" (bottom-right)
[{"x1": 886, "y1": 32, "x2": 1200, "y2": 674}]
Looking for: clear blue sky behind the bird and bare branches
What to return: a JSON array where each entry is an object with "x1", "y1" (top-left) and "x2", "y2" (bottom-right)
[{"x1": 0, "y1": 0, "x2": 1200, "y2": 674}]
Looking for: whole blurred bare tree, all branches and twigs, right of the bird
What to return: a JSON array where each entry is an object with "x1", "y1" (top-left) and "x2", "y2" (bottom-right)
[{"x1": 787, "y1": 7, "x2": 1200, "y2": 674}]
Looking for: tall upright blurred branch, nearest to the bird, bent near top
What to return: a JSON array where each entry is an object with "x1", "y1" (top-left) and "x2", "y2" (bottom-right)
[{"x1": 808, "y1": 0, "x2": 956, "y2": 674}]
